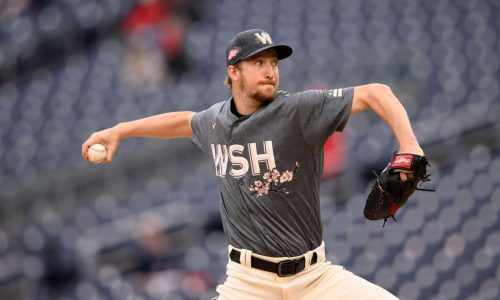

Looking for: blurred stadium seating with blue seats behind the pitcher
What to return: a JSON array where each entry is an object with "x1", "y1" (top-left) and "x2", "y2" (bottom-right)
[{"x1": 0, "y1": 0, "x2": 500, "y2": 300}]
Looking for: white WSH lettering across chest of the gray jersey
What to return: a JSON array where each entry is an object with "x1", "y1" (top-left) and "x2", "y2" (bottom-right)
[{"x1": 210, "y1": 141, "x2": 276, "y2": 178}]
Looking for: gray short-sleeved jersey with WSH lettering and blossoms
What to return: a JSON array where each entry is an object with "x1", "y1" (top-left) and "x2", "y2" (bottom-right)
[{"x1": 192, "y1": 88, "x2": 354, "y2": 257}]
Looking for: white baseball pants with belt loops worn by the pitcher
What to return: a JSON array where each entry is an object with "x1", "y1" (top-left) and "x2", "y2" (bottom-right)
[{"x1": 216, "y1": 243, "x2": 397, "y2": 300}]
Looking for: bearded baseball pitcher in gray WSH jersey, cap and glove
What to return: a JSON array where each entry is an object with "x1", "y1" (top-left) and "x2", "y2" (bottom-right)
[{"x1": 82, "y1": 29, "x2": 427, "y2": 300}]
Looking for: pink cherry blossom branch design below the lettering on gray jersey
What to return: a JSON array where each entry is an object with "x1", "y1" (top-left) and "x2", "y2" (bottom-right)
[{"x1": 248, "y1": 162, "x2": 299, "y2": 197}]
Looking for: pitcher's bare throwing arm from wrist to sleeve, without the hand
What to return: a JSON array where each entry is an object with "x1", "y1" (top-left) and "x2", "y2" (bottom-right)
[{"x1": 115, "y1": 111, "x2": 195, "y2": 140}]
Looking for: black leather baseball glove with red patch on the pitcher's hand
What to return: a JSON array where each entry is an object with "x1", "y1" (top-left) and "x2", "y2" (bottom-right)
[{"x1": 364, "y1": 153, "x2": 433, "y2": 226}]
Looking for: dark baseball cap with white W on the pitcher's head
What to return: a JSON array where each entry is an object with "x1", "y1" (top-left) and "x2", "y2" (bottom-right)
[{"x1": 226, "y1": 29, "x2": 293, "y2": 66}]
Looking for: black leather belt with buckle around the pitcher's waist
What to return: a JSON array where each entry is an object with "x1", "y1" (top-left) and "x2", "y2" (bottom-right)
[{"x1": 229, "y1": 249, "x2": 318, "y2": 277}]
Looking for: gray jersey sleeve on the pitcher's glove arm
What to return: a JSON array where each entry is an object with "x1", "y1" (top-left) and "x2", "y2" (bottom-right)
[{"x1": 298, "y1": 87, "x2": 354, "y2": 148}]
